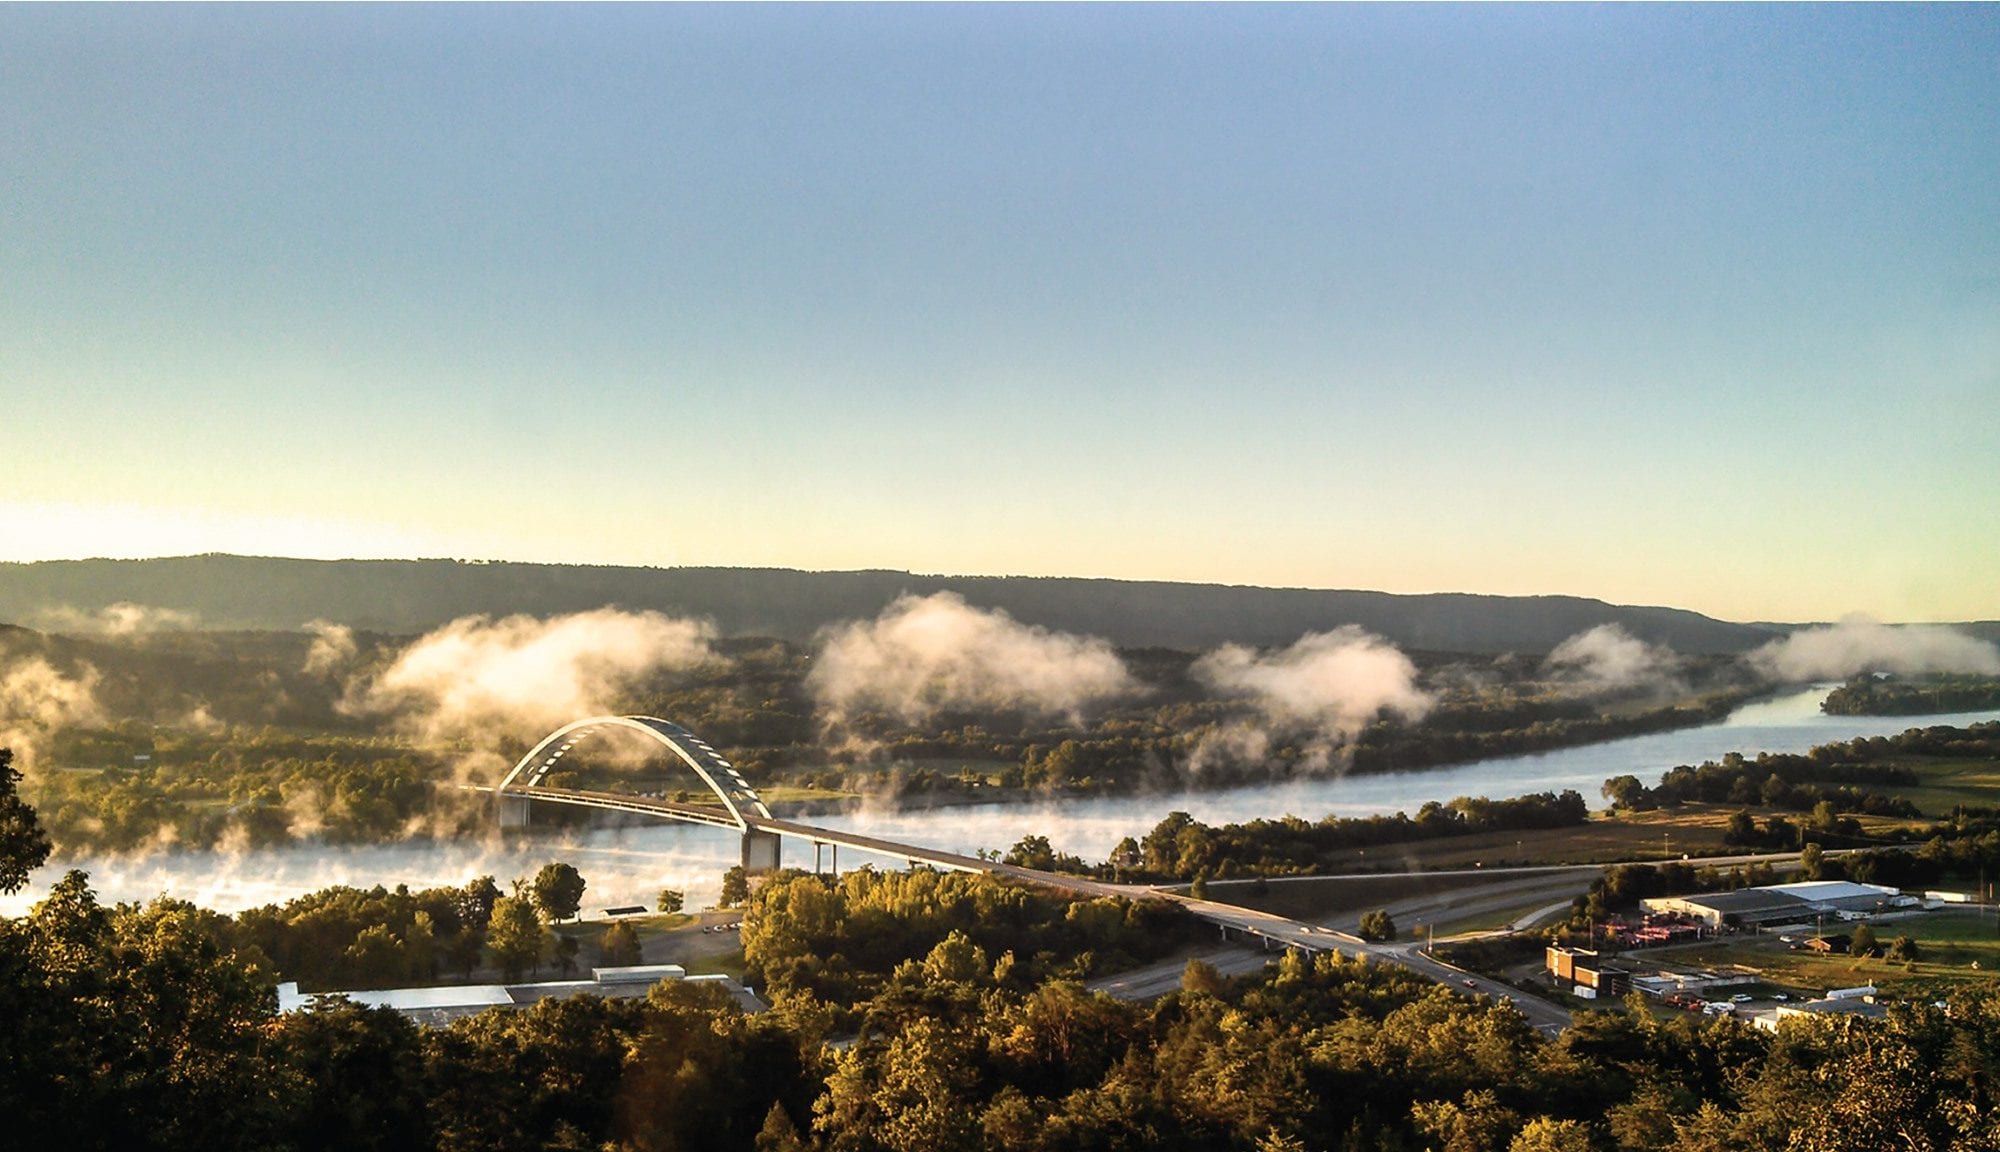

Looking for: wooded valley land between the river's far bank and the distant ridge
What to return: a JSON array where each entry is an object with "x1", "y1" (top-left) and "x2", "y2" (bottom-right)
[{"x1": 0, "y1": 628, "x2": 1756, "y2": 852}]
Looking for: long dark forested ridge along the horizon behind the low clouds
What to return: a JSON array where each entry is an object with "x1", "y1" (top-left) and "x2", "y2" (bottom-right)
[{"x1": 0, "y1": 556, "x2": 1774, "y2": 654}]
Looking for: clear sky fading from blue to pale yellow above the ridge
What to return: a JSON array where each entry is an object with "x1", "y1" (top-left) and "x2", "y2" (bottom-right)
[{"x1": 0, "y1": 4, "x2": 2000, "y2": 620}]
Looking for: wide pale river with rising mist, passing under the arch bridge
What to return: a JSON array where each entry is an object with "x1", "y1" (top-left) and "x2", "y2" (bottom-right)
[{"x1": 0, "y1": 686, "x2": 2000, "y2": 916}]
